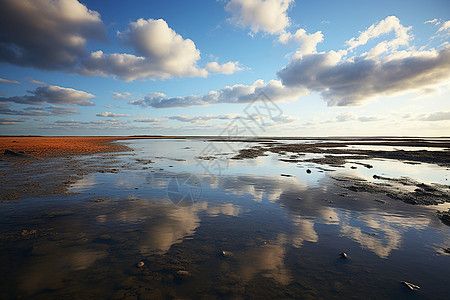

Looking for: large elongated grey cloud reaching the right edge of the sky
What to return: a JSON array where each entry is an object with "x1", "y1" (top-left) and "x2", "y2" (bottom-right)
[{"x1": 278, "y1": 46, "x2": 450, "y2": 106}]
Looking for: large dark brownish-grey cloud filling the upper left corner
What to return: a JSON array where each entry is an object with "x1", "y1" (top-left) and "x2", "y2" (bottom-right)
[{"x1": 0, "y1": 0, "x2": 106, "y2": 70}]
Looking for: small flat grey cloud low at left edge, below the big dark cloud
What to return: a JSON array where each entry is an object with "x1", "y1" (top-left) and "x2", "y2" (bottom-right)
[{"x1": 0, "y1": 85, "x2": 95, "y2": 106}]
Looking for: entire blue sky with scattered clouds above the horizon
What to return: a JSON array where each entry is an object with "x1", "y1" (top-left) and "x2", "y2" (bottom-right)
[{"x1": 0, "y1": 0, "x2": 450, "y2": 137}]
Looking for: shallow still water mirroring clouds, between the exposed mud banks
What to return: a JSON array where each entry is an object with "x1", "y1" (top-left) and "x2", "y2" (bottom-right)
[{"x1": 0, "y1": 140, "x2": 450, "y2": 299}]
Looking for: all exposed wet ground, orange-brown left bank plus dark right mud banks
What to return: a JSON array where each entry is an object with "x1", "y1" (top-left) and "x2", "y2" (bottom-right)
[{"x1": 0, "y1": 137, "x2": 450, "y2": 205}]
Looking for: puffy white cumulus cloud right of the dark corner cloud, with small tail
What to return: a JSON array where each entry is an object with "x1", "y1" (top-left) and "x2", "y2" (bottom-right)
[{"x1": 78, "y1": 19, "x2": 240, "y2": 81}]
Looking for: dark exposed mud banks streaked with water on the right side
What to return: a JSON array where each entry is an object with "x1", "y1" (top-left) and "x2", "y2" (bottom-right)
[{"x1": 229, "y1": 139, "x2": 450, "y2": 206}]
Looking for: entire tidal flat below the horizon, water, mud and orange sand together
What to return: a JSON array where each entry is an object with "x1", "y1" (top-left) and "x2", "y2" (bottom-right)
[{"x1": 0, "y1": 137, "x2": 450, "y2": 299}]
